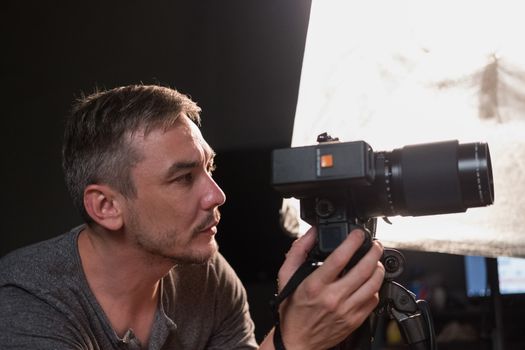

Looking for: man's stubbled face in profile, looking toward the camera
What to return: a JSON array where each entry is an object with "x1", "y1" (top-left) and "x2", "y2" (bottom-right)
[{"x1": 125, "y1": 115, "x2": 226, "y2": 263}]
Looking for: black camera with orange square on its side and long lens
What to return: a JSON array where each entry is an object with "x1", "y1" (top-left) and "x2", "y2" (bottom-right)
[{"x1": 272, "y1": 133, "x2": 494, "y2": 260}]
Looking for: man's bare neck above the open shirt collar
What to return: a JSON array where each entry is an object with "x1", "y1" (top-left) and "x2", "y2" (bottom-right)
[{"x1": 78, "y1": 227, "x2": 173, "y2": 345}]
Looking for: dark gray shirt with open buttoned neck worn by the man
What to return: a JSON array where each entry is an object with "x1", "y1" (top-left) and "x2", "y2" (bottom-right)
[{"x1": 0, "y1": 226, "x2": 257, "y2": 350}]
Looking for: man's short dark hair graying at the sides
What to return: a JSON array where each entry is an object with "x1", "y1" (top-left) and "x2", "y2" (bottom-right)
[{"x1": 62, "y1": 85, "x2": 201, "y2": 223}]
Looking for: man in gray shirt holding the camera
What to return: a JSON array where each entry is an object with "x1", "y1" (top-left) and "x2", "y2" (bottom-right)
[{"x1": 0, "y1": 85, "x2": 384, "y2": 350}]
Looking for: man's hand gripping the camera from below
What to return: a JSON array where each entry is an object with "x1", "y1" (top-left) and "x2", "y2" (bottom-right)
[{"x1": 279, "y1": 228, "x2": 384, "y2": 350}]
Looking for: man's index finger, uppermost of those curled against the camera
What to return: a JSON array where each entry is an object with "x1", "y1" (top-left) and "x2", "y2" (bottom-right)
[{"x1": 315, "y1": 229, "x2": 365, "y2": 284}]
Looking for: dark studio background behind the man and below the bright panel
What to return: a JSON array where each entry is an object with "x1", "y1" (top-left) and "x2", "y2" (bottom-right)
[{"x1": 0, "y1": 0, "x2": 523, "y2": 349}]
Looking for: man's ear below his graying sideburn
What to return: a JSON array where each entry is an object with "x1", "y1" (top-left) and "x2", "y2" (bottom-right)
[{"x1": 84, "y1": 184, "x2": 124, "y2": 231}]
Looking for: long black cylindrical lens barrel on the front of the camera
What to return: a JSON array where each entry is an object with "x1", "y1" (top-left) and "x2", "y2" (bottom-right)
[{"x1": 352, "y1": 141, "x2": 494, "y2": 217}]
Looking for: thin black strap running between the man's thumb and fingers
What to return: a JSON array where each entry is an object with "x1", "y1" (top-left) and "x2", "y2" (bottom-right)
[{"x1": 270, "y1": 260, "x2": 318, "y2": 350}]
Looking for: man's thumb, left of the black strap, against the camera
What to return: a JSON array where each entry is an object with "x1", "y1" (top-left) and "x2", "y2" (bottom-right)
[{"x1": 278, "y1": 227, "x2": 317, "y2": 291}]
